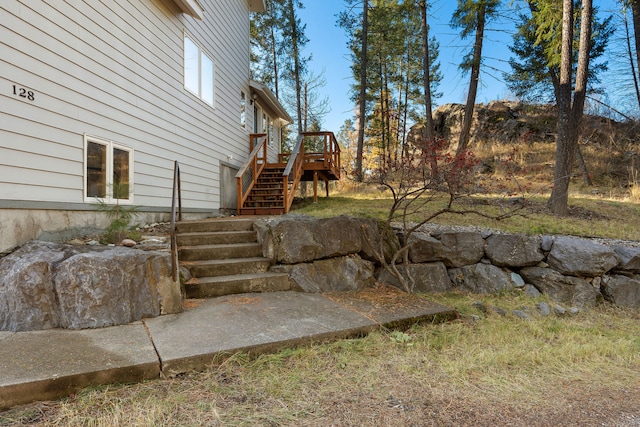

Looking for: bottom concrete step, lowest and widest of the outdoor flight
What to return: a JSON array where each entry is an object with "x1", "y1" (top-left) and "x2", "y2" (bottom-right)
[{"x1": 185, "y1": 272, "x2": 291, "y2": 298}]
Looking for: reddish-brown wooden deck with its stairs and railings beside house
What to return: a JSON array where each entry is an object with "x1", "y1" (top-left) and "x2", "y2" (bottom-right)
[{"x1": 236, "y1": 132, "x2": 340, "y2": 215}]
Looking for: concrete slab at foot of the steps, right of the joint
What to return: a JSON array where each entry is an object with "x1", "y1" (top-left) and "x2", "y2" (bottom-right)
[{"x1": 146, "y1": 292, "x2": 378, "y2": 375}]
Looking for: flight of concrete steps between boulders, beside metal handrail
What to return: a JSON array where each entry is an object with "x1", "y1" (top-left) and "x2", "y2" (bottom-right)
[{"x1": 176, "y1": 218, "x2": 291, "y2": 298}]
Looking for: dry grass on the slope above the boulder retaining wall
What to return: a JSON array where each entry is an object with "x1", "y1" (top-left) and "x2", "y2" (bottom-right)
[{"x1": 300, "y1": 142, "x2": 640, "y2": 240}]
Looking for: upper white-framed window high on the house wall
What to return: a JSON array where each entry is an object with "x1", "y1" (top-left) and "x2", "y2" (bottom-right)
[{"x1": 184, "y1": 33, "x2": 214, "y2": 106}]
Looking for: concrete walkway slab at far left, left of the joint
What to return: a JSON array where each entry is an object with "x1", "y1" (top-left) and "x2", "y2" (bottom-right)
[{"x1": 0, "y1": 322, "x2": 160, "y2": 409}]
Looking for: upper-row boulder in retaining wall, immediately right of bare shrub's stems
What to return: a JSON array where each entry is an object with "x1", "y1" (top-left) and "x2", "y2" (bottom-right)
[{"x1": 407, "y1": 231, "x2": 484, "y2": 268}]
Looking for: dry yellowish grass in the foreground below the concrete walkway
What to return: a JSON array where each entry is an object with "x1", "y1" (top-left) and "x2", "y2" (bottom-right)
[{"x1": 0, "y1": 293, "x2": 640, "y2": 426}]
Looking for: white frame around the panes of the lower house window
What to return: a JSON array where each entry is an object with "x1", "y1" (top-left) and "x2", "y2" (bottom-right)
[{"x1": 83, "y1": 134, "x2": 135, "y2": 204}]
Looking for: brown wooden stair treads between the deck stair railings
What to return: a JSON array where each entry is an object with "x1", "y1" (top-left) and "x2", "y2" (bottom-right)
[{"x1": 239, "y1": 164, "x2": 285, "y2": 215}]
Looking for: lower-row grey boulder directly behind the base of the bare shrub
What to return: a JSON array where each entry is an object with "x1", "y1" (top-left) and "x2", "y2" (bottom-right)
[{"x1": 378, "y1": 262, "x2": 453, "y2": 293}]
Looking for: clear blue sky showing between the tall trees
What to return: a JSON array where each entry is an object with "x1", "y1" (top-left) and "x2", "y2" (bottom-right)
[{"x1": 299, "y1": 0, "x2": 614, "y2": 133}]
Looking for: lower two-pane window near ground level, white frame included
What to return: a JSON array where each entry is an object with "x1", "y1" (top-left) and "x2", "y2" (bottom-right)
[{"x1": 84, "y1": 135, "x2": 133, "y2": 203}]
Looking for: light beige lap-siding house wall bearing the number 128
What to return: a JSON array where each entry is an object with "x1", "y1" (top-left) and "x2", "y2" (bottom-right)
[{"x1": 0, "y1": 0, "x2": 260, "y2": 252}]
